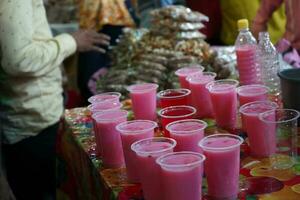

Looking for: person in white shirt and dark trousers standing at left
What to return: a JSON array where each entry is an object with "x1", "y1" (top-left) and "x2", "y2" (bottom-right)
[{"x1": 0, "y1": 0, "x2": 109, "y2": 200}]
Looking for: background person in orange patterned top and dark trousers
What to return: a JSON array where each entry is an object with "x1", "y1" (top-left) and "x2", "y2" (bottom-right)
[{"x1": 77, "y1": 0, "x2": 135, "y2": 104}]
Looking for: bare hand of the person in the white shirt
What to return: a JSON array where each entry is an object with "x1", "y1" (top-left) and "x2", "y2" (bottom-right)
[{"x1": 72, "y1": 30, "x2": 110, "y2": 53}]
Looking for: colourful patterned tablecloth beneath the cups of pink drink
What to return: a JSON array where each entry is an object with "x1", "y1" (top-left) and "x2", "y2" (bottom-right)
[{"x1": 57, "y1": 108, "x2": 300, "y2": 200}]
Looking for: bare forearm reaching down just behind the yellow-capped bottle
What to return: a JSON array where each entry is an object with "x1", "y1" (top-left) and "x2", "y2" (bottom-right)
[{"x1": 251, "y1": 0, "x2": 284, "y2": 37}]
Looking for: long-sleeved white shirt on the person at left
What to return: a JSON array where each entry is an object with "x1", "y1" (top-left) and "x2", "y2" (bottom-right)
[{"x1": 0, "y1": 0, "x2": 76, "y2": 143}]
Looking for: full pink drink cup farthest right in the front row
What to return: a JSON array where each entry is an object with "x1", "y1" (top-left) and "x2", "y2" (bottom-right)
[{"x1": 199, "y1": 134, "x2": 243, "y2": 199}]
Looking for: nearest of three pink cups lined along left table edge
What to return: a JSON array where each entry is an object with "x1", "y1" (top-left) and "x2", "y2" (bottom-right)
[{"x1": 95, "y1": 110, "x2": 128, "y2": 168}]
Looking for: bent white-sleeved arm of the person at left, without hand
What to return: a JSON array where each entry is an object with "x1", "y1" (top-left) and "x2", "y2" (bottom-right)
[{"x1": 0, "y1": 0, "x2": 76, "y2": 76}]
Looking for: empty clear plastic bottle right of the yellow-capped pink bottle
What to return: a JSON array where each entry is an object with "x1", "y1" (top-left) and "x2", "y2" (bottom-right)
[{"x1": 258, "y1": 32, "x2": 281, "y2": 101}]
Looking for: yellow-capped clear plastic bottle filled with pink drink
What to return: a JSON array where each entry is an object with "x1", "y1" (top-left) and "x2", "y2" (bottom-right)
[{"x1": 235, "y1": 19, "x2": 261, "y2": 85}]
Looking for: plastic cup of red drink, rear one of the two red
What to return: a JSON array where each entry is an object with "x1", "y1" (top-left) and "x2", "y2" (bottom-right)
[{"x1": 157, "y1": 89, "x2": 191, "y2": 108}]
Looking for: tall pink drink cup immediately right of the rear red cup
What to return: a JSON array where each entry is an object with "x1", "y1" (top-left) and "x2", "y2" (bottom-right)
[{"x1": 186, "y1": 72, "x2": 217, "y2": 118}]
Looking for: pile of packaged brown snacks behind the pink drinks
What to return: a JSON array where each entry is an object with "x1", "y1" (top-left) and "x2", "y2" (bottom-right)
[{"x1": 97, "y1": 6, "x2": 235, "y2": 94}]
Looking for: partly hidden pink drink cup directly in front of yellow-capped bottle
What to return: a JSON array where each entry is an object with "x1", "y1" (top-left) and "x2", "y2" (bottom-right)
[{"x1": 237, "y1": 84, "x2": 269, "y2": 106}]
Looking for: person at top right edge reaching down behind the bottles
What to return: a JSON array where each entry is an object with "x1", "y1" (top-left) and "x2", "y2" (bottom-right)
[{"x1": 251, "y1": 0, "x2": 300, "y2": 67}]
